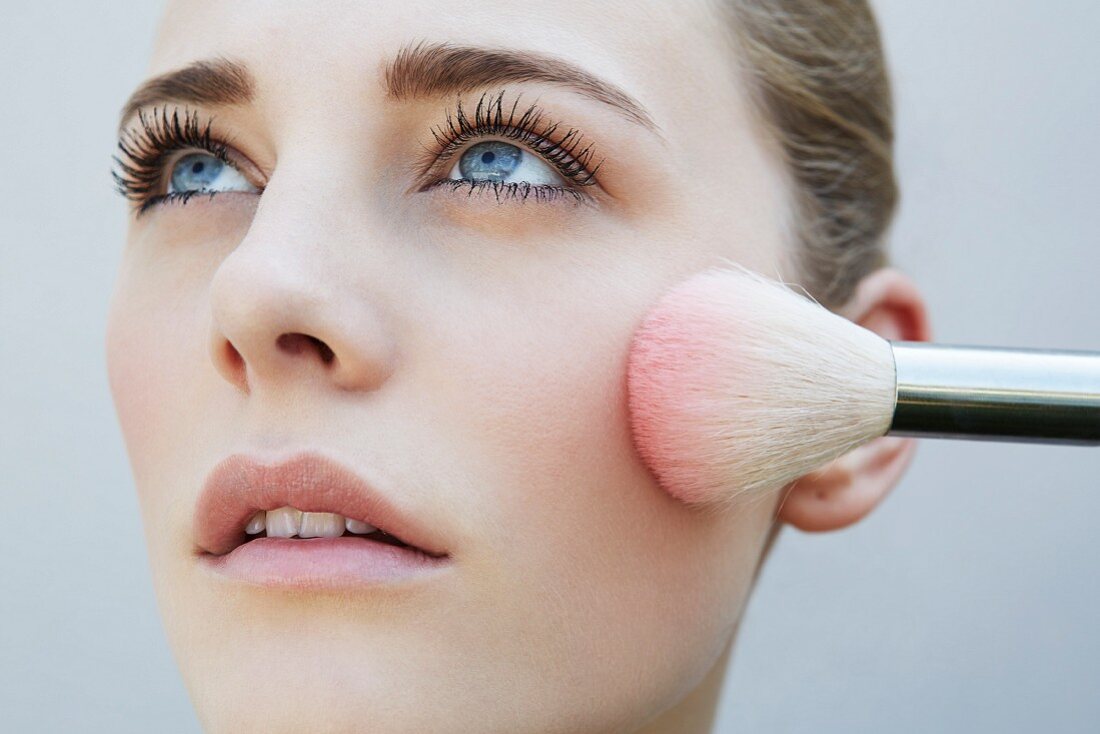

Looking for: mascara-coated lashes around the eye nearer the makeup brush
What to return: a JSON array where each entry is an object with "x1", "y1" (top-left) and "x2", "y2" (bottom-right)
[{"x1": 420, "y1": 90, "x2": 603, "y2": 202}]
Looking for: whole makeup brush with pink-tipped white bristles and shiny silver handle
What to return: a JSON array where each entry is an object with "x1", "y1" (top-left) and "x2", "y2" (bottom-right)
[{"x1": 627, "y1": 264, "x2": 1100, "y2": 505}]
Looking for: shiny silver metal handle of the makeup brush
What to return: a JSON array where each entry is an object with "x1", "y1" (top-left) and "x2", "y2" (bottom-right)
[{"x1": 888, "y1": 341, "x2": 1100, "y2": 446}]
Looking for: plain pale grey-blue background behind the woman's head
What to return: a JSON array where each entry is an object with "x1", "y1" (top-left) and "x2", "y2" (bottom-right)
[{"x1": 0, "y1": 0, "x2": 1100, "y2": 733}]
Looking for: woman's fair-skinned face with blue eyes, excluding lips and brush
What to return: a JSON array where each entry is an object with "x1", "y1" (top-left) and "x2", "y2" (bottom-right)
[{"x1": 107, "y1": 0, "x2": 787, "y2": 733}]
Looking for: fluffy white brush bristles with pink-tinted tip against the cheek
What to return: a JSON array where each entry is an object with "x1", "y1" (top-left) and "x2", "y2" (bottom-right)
[{"x1": 627, "y1": 265, "x2": 895, "y2": 505}]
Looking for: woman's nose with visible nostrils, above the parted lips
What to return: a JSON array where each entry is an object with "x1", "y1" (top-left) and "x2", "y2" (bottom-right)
[{"x1": 210, "y1": 217, "x2": 395, "y2": 393}]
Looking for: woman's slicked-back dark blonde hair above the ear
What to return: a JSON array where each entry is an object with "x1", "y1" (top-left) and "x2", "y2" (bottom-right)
[{"x1": 715, "y1": 0, "x2": 898, "y2": 307}]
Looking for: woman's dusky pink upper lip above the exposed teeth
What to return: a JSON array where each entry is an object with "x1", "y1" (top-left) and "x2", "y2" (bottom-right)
[{"x1": 193, "y1": 452, "x2": 447, "y2": 556}]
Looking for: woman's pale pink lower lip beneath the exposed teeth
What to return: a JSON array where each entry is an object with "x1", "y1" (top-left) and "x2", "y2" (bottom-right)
[{"x1": 200, "y1": 536, "x2": 450, "y2": 589}]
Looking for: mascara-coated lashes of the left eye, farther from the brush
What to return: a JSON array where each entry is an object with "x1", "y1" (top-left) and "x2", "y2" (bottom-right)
[{"x1": 111, "y1": 107, "x2": 233, "y2": 215}]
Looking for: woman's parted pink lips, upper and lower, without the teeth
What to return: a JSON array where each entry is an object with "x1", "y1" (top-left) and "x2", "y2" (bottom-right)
[{"x1": 193, "y1": 452, "x2": 450, "y2": 588}]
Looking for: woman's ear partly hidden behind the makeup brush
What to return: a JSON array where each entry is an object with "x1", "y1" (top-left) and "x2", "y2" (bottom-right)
[{"x1": 778, "y1": 267, "x2": 932, "y2": 532}]
